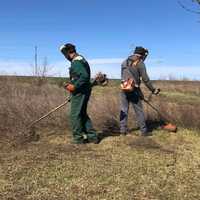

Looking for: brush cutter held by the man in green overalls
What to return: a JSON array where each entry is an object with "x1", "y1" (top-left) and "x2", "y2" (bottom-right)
[{"x1": 27, "y1": 72, "x2": 108, "y2": 141}]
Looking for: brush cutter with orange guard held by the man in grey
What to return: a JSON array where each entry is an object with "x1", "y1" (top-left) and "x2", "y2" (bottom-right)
[{"x1": 143, "y1": 90, "x2": 177, "y2": 132}]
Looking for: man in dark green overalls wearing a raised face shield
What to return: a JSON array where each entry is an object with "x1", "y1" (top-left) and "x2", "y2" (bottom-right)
[{"x1": 60, "y1": 44, "x2": 99, "y2": 144}]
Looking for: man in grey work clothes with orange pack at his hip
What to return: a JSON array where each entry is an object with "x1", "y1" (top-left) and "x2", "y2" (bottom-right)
[{"x1": 120, "y1": 47, "x2": 160, "y2": 136}]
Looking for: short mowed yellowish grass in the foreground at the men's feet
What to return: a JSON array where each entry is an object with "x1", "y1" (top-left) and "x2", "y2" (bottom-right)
[{"x1": 0, "y1": 130, "x2": 200, "y2": 200}]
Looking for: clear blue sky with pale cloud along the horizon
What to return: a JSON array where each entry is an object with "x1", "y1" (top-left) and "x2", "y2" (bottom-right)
[{"x1": 0, "y1": 0, "x2": 200, "y2": 79}]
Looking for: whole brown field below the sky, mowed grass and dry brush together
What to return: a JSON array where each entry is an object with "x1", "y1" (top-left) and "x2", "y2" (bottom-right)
[{"x1": 0, "y1": 77, "x2": 200, "y2": 200}]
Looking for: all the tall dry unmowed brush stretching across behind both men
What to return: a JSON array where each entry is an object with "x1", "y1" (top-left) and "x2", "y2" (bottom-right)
[{"x1": 0, "y1": 77, "x2": 200, "y2": 141}]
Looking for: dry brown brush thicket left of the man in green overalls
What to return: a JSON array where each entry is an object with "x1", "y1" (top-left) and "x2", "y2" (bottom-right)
[{"x1": 0, "y1": 78, "x2": 67, "y2": 138}]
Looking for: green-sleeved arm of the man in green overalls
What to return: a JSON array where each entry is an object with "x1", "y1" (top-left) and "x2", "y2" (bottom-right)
[{"x1": 71, "y1": 61, "x2": 90, "y2": 90}]
